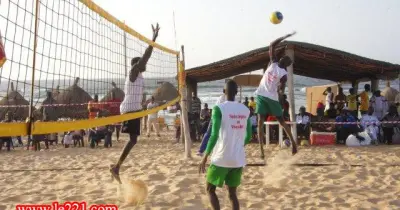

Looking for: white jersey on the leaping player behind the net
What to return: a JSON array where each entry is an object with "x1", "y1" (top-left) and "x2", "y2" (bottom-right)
[{"x1": 120, "y1": 73, "x2": 144, "y2": 114}]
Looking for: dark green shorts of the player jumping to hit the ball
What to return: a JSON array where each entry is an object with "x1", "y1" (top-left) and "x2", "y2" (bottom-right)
[{"x1": 256, "y1": 95, "x2": 283, "y2": 117}]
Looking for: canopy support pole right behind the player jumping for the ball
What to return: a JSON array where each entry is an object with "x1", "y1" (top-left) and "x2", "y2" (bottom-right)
[{"x1": 285, "y1": 48, "x2": 297, "y2": 142}]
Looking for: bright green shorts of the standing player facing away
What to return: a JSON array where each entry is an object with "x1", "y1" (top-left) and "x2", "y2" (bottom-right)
[{"x1": 207, "y1": 164, "x2": 243, "y2": 187}]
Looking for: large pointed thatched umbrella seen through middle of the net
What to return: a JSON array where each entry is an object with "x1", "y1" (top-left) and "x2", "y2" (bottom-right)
[{"x1": 54, "y1": 77, "x2": 93, "y2": 119}]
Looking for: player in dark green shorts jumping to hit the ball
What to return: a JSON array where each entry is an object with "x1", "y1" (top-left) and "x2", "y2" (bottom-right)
[{"x1": 255, "y1": 32, "x2": 297, "y2": 156}]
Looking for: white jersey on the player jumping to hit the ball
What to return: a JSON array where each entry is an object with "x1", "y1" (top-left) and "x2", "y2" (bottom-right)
[{"x1": 255, "y1": 62, "x2": 287, "y2": 101}]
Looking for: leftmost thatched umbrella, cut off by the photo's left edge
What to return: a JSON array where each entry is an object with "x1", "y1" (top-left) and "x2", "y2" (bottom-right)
[{"x1": 0, "y1": 82, "x2": 29, "y2": 120}]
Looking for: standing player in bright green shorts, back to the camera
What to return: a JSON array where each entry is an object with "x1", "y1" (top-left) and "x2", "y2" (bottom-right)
[{"x1": 199, "y1": 80, "x2": 252, "y2": 210}]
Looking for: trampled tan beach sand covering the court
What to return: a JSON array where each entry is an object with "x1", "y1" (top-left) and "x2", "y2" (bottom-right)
[{"x1": 0, "y1": 132, "x2": 400, "y2": 210}]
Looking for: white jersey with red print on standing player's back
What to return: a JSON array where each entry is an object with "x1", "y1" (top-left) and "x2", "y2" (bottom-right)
[{"x1": 211, "y1": 101, "x2": 250, "y2": 168}]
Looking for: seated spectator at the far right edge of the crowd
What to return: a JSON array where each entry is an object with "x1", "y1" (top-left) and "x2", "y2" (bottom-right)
[{"x1": 382, "y1": 105, "x2": 400, "y2": 144}]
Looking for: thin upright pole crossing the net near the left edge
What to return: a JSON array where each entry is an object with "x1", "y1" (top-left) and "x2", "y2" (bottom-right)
[{"x1": 27, "y1": 0, "x2": 40, "y2": 136}]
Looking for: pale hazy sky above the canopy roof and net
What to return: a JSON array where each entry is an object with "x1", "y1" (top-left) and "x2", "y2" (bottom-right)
[{"x1": 94, "y1": 0, "x2": 400, "y2": 68}]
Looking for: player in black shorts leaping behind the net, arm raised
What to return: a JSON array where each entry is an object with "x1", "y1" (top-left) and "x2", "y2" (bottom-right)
[{"x1": 110, "y1": 23, "x2": 160, "y2": 184}]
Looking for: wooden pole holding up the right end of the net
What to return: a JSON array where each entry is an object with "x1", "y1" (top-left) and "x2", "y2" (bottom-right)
[{"x1": 179, "y1": 45, "x2": 192, "y2": 158}]
